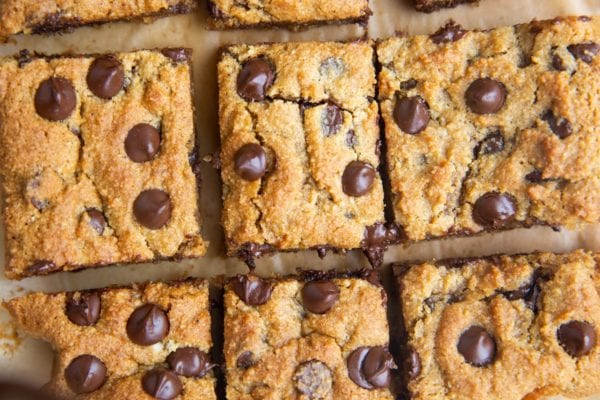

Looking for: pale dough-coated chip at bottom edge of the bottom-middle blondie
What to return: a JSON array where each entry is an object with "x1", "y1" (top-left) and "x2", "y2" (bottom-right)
[{"x1": 292, "y1": 360, "x2": 333, "y2": 400}]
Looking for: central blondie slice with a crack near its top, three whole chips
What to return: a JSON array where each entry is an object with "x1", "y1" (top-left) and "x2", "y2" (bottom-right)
[{"x1": 218, "y1": 41, "x2": 389, "y2": 268}]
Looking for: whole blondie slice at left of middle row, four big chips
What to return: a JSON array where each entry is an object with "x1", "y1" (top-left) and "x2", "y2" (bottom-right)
[{"x1": 0, "y1": 49, "x2": 205, "y2": 278}]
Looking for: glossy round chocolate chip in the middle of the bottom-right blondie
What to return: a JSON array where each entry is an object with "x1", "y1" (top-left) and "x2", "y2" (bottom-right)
[{"x1": 457, "y1": 326, "x2": 496, "y2": 367}]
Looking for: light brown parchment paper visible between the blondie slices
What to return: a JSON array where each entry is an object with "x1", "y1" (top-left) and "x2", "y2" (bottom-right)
[{"x1": 0, "y1": 0, "x2": 600, "y2": 399}]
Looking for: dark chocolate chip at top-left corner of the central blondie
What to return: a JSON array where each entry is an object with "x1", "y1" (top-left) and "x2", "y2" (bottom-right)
[{"x1": 237, "y1": 57, "x2": 275, "y2": 101}]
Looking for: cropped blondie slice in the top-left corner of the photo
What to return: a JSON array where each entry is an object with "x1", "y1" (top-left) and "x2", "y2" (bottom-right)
[{"x1": 0, "y1": 0, "x2": 196, "y2": 42}]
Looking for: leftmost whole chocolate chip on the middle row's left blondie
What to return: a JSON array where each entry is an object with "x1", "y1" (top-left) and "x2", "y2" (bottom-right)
[{"x1": 34, "y1": 77, "x2": 77, "y2": 121}]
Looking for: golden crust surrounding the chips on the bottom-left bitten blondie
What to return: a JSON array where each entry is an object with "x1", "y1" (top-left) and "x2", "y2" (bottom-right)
[{"x1": 5, "y1": 280, "x2": 216, "y2": 400}]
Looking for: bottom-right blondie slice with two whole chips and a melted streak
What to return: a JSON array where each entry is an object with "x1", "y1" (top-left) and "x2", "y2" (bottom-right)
[{"x1": 393, "y1": 251, "x2": 600, "y2": 400}]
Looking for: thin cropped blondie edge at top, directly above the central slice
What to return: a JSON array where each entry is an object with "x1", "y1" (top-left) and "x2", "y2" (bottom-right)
[{"x1": 208, "y1": 0, "x2": 371, "y2": 29}]
